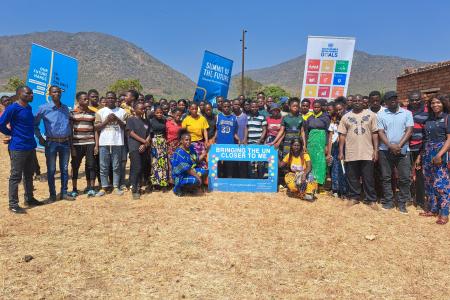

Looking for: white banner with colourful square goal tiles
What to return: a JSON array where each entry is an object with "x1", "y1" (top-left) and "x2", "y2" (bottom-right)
[{"x1": 302, "y1": 36, "x2": 355, "y2": 101}]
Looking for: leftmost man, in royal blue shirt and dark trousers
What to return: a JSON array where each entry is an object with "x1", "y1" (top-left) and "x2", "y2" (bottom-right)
[{"x1": 0, "y1": 86, "x2": 43, "y2": 214}]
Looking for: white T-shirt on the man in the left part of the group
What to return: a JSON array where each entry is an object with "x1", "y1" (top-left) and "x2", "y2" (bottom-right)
[{"x1": 95, "y1": 107, "x2": 128, "y2": 146}]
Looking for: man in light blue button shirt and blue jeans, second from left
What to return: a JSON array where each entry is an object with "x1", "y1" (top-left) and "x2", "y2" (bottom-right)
[{"x1": 34, "y1": 86, "x2": 75, "y2": 202}]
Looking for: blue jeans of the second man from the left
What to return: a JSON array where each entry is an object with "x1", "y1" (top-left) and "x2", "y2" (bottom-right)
[{"x1": 45, "y1": 141, "x2": 70, "y2": 197}]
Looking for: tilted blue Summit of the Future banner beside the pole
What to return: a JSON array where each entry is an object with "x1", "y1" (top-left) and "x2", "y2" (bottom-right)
[{"x1": 194, "y1": 51, "x2": 233, "y2": 105}]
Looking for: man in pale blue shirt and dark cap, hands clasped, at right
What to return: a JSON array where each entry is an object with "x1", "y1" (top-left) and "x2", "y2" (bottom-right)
[{"x1": 378, "y1": 91, "x2": 414, "y2": 214}]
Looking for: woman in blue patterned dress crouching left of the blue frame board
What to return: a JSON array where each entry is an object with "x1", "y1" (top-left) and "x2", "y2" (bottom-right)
[{"x1": 171, "y1": 129, "x2": 208, "y2": 196}]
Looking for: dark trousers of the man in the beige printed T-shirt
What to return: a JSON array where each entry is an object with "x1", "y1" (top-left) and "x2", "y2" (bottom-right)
[{"x1": 345, "y1": 160, "x2": 377, "y2": 202}]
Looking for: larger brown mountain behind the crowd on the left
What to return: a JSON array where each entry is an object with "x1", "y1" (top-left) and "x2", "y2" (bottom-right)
[{"x1": 0, "y1": 31, "x2": 195, "y2": 98}]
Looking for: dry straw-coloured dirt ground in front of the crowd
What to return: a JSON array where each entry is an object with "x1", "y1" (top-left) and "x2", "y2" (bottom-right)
[{"x1": 0, "y1": 147, "x2": 450, "y2": 299}]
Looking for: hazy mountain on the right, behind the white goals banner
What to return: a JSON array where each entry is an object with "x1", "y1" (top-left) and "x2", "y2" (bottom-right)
[{"x1": 232, "y1": 51, "x2": 430, "y2": 95}]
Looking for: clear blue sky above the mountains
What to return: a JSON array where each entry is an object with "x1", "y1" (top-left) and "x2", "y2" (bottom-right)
[{"x1": 0, "y1": 0, "x2": 450, "y2": 81}]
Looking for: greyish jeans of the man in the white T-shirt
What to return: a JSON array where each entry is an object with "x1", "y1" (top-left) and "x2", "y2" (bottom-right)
[{"x1": 99, "y1": 146, "x2": 123, "y2": 188}]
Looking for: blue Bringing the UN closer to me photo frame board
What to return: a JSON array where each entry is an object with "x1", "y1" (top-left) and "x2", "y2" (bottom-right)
[{"x1": 208, "y1": 144, "x2": 278, "y2": 193}]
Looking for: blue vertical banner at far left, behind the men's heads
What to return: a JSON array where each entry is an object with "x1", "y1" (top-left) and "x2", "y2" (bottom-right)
[{"x1": 26, "y1": 44, "x2": 78, "y2": 110}]
